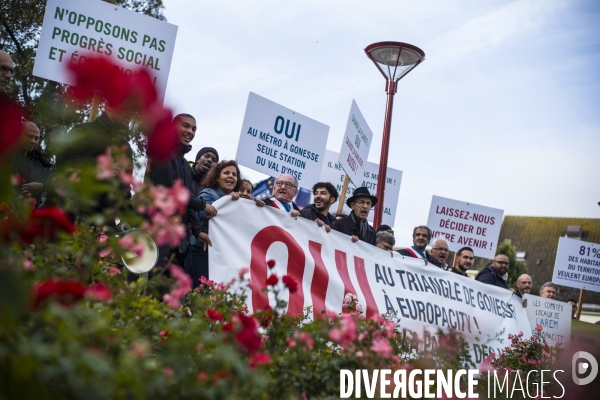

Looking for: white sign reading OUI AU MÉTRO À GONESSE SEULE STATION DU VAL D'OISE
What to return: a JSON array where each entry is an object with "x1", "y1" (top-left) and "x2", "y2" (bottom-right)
[{"x1": 235, "y1": 92, "x2": 329, "y2": 189}]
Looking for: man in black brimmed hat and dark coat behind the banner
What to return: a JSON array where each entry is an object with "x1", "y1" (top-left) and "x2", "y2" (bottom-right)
[{"x1": 331, "y1": 187, "x2": 377, "y2": 246}]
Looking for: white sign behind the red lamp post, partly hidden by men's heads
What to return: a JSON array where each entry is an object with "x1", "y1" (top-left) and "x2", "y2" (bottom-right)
[{"x1": 320, "y1": 150, "x2": 402, "y2": 226}]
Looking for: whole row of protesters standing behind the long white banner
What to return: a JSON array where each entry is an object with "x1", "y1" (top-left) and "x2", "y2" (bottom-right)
[{"x1": 0, "y1": 50, "x2": 576, "y2": 314}]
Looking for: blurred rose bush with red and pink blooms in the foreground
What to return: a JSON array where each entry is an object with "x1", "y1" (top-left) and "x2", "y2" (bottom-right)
[{"x1": 0, "y1": 54, "x2": 564, "y2": 400}]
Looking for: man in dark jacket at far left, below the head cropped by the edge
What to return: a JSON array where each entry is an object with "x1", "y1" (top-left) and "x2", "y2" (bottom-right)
[{"x1": 10, "y1": 121, "x2": 52, "y2": 206}]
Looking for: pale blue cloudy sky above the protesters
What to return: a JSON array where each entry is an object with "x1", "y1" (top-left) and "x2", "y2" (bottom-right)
[{"x1": 164, "y1": 0, "x2": 600, "y2": 246}]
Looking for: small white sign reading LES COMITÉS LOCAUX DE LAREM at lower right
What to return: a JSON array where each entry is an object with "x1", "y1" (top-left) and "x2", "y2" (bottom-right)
[{"x1": 523, "y1": 293, "x2": 573, "y2": 349}]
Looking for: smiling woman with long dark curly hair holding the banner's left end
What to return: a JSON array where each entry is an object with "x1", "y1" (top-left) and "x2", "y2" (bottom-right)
[{"x1": 184, "y1": 160, "x2": 242, "y2": 288}]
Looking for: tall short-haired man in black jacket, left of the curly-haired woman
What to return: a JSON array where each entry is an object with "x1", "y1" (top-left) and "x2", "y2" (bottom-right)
[{"x1": 146, "y1": 114, "x2": 217, "y2": 265}]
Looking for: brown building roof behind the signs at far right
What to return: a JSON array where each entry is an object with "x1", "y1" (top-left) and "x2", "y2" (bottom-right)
[{"x1": 498, "y1": 216, "x2": 600, "y2": 304}]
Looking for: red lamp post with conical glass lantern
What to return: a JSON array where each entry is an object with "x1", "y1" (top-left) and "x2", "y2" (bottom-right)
[{"x1": 365, "y1": 42, "x2": 425, "y2": 229}]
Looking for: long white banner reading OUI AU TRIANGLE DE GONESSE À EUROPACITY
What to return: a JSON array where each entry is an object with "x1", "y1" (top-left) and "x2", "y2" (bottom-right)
[{"x1": 209, "y1": 196, "x2": 529, "y2": 364}]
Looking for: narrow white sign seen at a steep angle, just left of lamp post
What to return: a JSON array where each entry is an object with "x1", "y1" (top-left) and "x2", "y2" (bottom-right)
[{"x1": 339, "y1": 100, "x2": 373, "y2": 182}]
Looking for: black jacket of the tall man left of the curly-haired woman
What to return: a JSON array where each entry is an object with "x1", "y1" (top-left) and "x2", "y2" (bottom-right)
[{"x1": 147, "y1": 144, "x2": 206, "y2": 237}]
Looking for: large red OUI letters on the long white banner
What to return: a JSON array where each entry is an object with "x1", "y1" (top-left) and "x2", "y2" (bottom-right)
[{"x1": 250, "y1": 226, "x2": 379, "y2": 318}]
